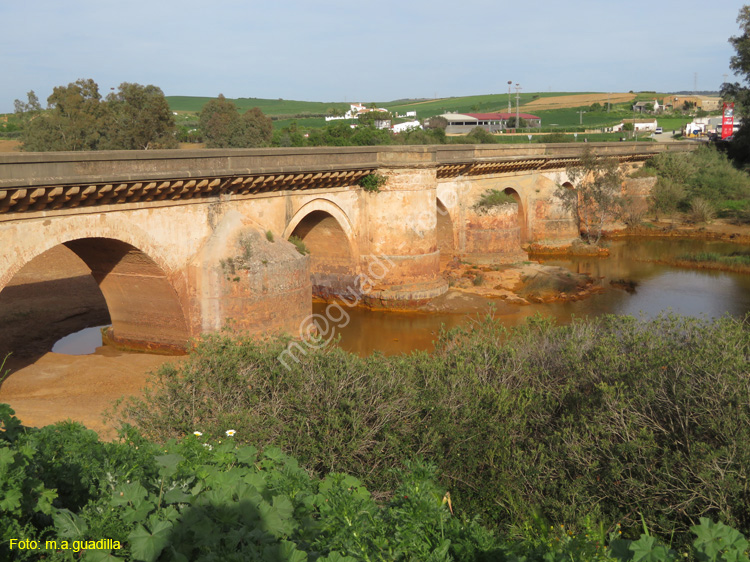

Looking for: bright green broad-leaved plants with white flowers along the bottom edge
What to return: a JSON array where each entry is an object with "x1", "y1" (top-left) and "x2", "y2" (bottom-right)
[{"x1": 0, "y1": 404, "x2": 750, "y2": 562}]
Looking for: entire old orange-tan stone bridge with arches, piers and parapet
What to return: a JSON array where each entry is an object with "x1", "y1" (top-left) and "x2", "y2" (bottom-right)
[{"x1": 0, "y1": 143, "x2": 683, "y2": 348}]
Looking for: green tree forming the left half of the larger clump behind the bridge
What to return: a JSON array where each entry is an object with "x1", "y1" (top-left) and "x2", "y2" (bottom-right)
[{"x1": 21, "y1": 79, "x2": 105, "y2": 151}]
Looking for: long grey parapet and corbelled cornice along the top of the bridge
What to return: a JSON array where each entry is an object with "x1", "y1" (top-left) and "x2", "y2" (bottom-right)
[{"x1": 0, "y1": 143, "x2": 694, "y2": 220}]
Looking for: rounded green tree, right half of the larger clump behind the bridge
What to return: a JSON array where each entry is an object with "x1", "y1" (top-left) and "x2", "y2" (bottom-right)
[{"x1": 101, "y1": 82, "x2": 177, "y2": 150}]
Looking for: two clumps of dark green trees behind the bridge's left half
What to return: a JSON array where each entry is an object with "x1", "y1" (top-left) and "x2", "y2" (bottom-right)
[{"x1": 14, "y1": 79, "x2": 273, "y2": 152}]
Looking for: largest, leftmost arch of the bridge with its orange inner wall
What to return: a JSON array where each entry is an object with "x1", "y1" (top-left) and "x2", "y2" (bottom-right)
[{"x1": 0, "y1": 221, "x2": 190, "y2": 351}]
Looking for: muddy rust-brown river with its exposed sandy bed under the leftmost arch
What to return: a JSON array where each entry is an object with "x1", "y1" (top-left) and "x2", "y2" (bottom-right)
[{"x1": 0, "y1": 239, "x2": 750, "y2": 437}]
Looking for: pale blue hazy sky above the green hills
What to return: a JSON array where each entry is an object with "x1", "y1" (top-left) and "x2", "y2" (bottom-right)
[{"x1": 0, "y1": 0, "x2": 744, "y2": 112}]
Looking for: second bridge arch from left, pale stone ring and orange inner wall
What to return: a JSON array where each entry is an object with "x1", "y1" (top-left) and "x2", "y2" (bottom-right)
[{"x1": 283, "y1": 199, "x2": 358, "y2": 298}]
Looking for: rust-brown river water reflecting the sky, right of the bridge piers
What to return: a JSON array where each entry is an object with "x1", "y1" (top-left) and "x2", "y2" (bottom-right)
[{"x1": 326, "y1": 240, "x2": 750, "y2": 355}]
